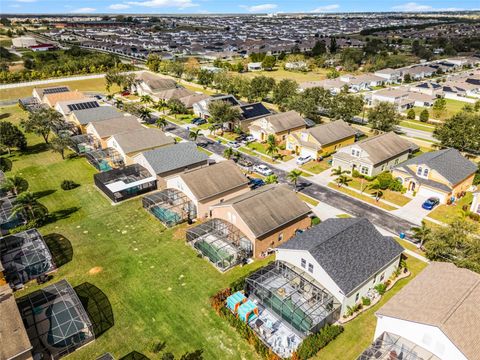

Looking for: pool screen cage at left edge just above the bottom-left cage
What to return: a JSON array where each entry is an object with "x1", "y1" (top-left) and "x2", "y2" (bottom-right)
[{"x1": 0, "y1": 229, "x2": 55, "y2": 287}]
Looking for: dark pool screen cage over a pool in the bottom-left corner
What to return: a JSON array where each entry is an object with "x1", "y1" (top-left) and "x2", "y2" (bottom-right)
[{"x1": 17, "y1": 280, "x2": 95, "y2": 359}]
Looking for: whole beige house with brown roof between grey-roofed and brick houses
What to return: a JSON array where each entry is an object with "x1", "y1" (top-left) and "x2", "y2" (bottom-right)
[{"x1": 167, "y1": 161, "x2": 250, "y2": 218}]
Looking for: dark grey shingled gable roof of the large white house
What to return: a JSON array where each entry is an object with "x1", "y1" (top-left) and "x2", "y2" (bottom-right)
[{"x1": 279, "y1": 218, "x2": 403, "y2": 296}]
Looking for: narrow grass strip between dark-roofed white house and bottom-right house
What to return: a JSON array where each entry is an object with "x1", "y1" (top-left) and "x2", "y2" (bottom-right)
[{"x1": 314, "y1": 256, "x2": 427, "y2": 360}]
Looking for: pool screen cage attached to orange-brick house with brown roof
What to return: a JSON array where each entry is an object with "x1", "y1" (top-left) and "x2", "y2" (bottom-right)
[{"x1": 187, "y1": 219, "x2": 252, "y2": 271}]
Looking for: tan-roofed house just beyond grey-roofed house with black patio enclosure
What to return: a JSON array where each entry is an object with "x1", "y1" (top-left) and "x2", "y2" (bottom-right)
[{"x1": 106, "y1": 127, "x2": 175, "y2": 165}]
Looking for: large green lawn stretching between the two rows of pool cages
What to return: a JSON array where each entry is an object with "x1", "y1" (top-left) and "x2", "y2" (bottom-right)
[{"x1": 1, "y1": 107, "x2": 268, "y2": 359}]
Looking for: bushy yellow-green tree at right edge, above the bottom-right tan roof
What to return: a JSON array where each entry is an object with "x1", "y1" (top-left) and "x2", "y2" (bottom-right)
[{"x1": 425, "y1": 219, "x2": 480, "y2": 273}]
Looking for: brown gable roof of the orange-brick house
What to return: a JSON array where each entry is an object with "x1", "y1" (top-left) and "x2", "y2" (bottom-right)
[{"x1": 212, "y1": 185, "x2": 310, "y2": 238}]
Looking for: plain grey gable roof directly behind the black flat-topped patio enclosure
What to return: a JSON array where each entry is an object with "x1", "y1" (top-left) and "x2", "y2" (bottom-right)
[{"x1": 142, "y1": 141, "x2": 208, "y2": 174}]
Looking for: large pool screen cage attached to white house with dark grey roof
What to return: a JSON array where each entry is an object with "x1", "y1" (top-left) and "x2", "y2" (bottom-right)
[{"x1": 245, "y1": 261, "x2": 340, "y2": 335}]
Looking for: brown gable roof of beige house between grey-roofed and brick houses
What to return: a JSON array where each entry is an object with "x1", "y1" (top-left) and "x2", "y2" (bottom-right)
[{"x1": 180, "y1": 160, "x2": 248, "y2": 200}]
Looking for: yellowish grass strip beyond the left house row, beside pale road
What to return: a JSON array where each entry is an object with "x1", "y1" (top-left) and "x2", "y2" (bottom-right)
[{"x1": 0, "y1": 78, "x2": 119, "y2": 100}]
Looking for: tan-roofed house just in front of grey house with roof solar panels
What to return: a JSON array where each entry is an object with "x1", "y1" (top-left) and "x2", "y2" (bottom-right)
[{"x1": 85, "y1": 115, "x2": 145, "y2": 149}]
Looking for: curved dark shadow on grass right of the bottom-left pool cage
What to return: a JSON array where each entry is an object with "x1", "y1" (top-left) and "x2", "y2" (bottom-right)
[{"x1": 74, "y1": 282, "x2": 115, "y2": 338}]
